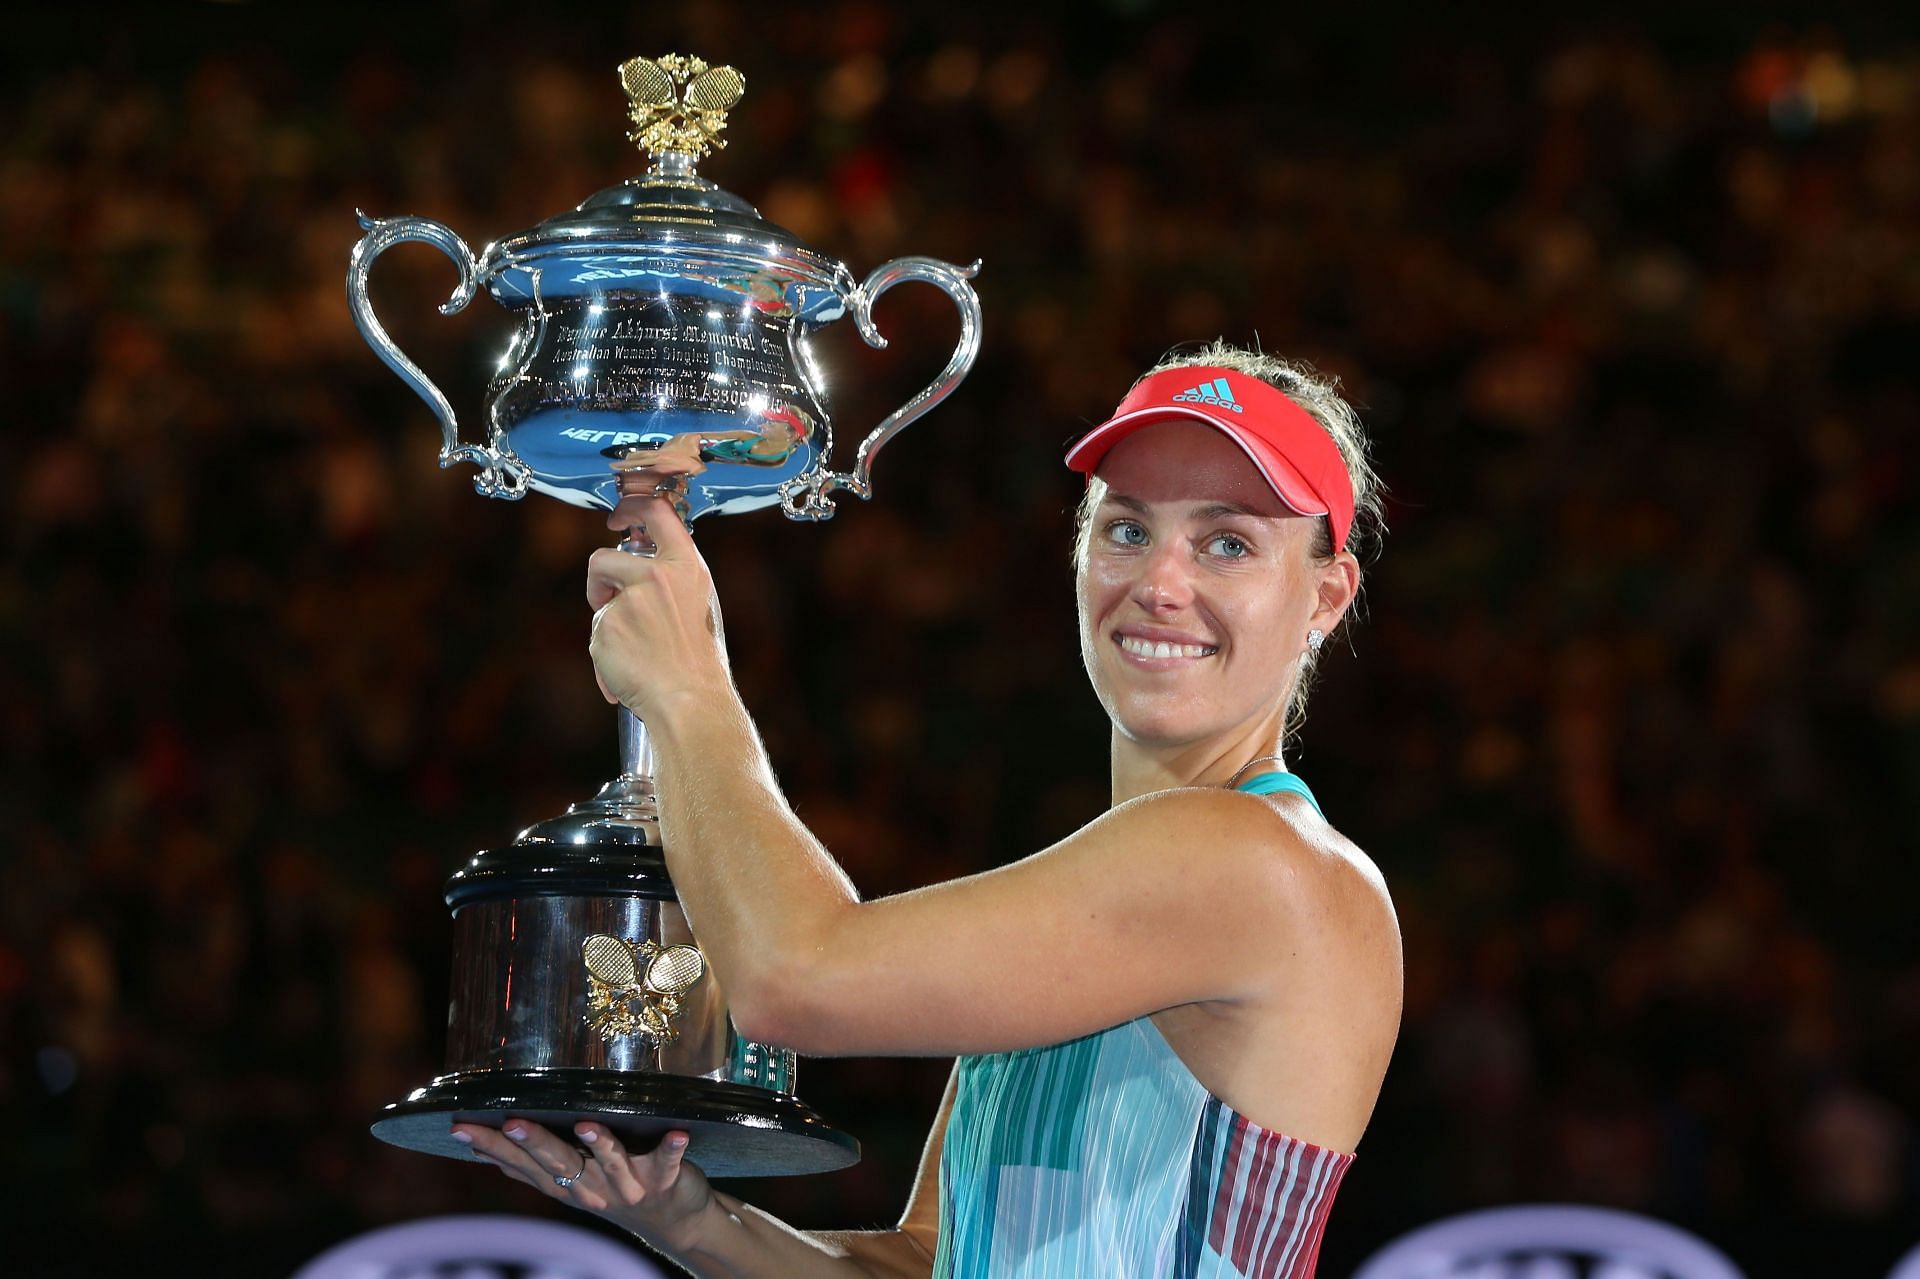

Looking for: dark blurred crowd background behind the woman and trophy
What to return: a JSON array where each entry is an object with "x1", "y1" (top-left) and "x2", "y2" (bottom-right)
[{"x1": 0, "y1": 0, "x2": 1920, "y2": 1275}]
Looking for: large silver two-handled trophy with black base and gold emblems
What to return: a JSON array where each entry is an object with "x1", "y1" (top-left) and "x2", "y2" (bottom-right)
[{"x1": 348, "y1": 54, "x2": 979, "y2": 1177}]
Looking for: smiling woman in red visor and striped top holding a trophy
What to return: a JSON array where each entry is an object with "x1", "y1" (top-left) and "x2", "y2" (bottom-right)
[{"x1": 455, "y1": 344, "x2": 1402, "y2": 1277}]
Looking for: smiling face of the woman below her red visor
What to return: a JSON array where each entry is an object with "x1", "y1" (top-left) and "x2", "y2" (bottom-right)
[{"x1": 1077, "y1": 421, "x2": 1357, "y2": 747}]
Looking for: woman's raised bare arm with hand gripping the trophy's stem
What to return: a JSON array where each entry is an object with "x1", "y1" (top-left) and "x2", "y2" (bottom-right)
[{"x1": 589, "y1": 505, "x2": 1371, "y2": 1054}]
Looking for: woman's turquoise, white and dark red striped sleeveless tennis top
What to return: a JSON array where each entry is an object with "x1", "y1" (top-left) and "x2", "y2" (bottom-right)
[{"x1": 933, "y1": 772, "x2": 1354, "y2": 1279}]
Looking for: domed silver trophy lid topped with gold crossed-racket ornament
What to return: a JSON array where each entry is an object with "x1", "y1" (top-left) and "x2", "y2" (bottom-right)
[{"x1": 482, "y1": 54, "x2": 851, "y2": 284}]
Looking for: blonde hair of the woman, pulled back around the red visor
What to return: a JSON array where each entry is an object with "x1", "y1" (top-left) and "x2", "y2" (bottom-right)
[{"x1": 1073, "y1": 340, "x2": 1386, "y2": 737}]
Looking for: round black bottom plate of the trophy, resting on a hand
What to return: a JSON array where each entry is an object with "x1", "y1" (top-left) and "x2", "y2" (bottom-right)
[{"x1": 372, "y1": 1068, "x2": 860, "y2": 1177}]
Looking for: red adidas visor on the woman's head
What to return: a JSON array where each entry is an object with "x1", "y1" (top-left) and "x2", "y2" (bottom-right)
[{"x1": 1068, "y1": 365, "x2": 1354, "y2": 551}]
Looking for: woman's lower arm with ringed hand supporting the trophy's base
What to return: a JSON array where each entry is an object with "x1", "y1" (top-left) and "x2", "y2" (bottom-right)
[{"x1": 453, "y1": 1066, "x2": 958, "y2": 1279}]
